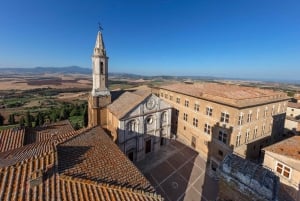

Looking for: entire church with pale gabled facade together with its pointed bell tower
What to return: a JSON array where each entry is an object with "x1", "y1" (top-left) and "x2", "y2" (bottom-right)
[{"x1": 88, "y1": 31, "x2": 172, "y2": 161}]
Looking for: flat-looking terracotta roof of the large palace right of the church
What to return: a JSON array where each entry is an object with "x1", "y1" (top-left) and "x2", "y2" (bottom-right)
[{"x1": 160, "y1": 83, "x2": 288, "y2": 107}]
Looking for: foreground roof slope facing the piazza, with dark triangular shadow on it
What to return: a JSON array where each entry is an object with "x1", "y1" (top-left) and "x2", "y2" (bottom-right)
[{"x1": 57, "y1": 127, "x2": 154, "y2": 192}]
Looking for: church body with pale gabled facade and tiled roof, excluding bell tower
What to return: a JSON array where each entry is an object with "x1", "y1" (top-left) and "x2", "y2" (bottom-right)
[{"x1": 107, "y1": 90, "x2": 171, "y2": 161}]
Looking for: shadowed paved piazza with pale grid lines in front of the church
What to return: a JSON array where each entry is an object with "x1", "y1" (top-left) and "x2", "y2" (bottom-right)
[{"x1": 136, "y1": 140, "x2": 218, "y2": 201}]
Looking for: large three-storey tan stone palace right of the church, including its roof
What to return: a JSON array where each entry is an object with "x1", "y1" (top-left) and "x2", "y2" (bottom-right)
[{"x1": 155, "y1": 83, "x2": 288, "y2": 170}]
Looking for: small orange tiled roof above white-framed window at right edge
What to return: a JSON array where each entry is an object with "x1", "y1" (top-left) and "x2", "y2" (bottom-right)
[{"x1": 264, "y1": 136, "x2": 300, "y2": 160}]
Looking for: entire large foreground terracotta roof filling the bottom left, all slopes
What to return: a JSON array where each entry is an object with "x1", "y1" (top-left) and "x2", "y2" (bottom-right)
[{"x1": 0, "y1": 127, "x2": 163, "y2": 201}]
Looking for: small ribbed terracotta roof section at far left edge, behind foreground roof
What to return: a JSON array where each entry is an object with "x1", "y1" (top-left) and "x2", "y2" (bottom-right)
[{"x1": 0, "y1": 128, "x2": 25, "y2": 152}]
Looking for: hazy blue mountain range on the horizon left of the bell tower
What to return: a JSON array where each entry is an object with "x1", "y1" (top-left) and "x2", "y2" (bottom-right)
[{"x1": 0, "y1": 66, "x2": 92, "y2": 75}]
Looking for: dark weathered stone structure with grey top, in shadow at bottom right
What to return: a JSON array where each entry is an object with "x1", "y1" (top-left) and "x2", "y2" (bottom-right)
[{"x1": 217, "y1": 154, "x2": 280, "y2": 201}]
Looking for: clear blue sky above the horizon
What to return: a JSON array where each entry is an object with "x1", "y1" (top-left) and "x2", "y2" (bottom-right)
[{"x1": 0, "y1": 0, "x2": 300, "y2": 80}]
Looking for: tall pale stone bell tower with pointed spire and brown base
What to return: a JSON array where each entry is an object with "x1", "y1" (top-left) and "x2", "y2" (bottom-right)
[{"x1": 88, "y1": 30, "x2": 111, "y2": 127}]
